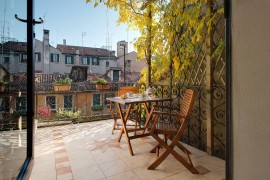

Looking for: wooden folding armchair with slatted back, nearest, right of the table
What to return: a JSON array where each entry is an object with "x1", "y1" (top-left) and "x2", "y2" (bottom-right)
[{"x1": 148, "y1": 89, "x2": 199, "y2": 174}]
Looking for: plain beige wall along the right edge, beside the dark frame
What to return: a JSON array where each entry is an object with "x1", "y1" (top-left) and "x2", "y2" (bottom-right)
[{"x1": 231, "y1": 0, "x2": 270, "y2": 180}]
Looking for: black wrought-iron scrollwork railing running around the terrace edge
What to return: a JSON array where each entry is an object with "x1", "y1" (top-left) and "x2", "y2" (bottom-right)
[{"x1": 0, "y1": 82, "x2": 226, "y2": 159}]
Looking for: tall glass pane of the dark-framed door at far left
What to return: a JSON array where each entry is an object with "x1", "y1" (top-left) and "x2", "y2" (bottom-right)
[{"x1": 0, "y1": 0, "x2": 28, "y2": 179}]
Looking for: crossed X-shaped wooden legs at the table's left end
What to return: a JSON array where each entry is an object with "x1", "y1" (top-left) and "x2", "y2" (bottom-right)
[{"x1": 117, "y1": 104, "x2": 134, "y2": 156}]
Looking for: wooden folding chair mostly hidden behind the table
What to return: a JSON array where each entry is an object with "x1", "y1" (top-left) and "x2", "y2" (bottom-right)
[{"x1": 112, "y1": 86, "x2": 140, "y2": 135}]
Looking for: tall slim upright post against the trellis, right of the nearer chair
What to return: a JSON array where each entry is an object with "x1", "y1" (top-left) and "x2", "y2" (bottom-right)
[{"x1": 205, "y1": 0, "x2": 214, "y2": 155}]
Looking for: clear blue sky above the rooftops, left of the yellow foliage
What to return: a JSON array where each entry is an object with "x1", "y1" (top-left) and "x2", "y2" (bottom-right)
[{"x1": 35, "y1": 0, "x2": 140, "y2": 52}]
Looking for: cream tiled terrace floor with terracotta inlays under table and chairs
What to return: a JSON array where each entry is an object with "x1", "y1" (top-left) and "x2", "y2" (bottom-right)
[{"x1": 30, "y1": 120, "x2": 225, "y2": 180}]
